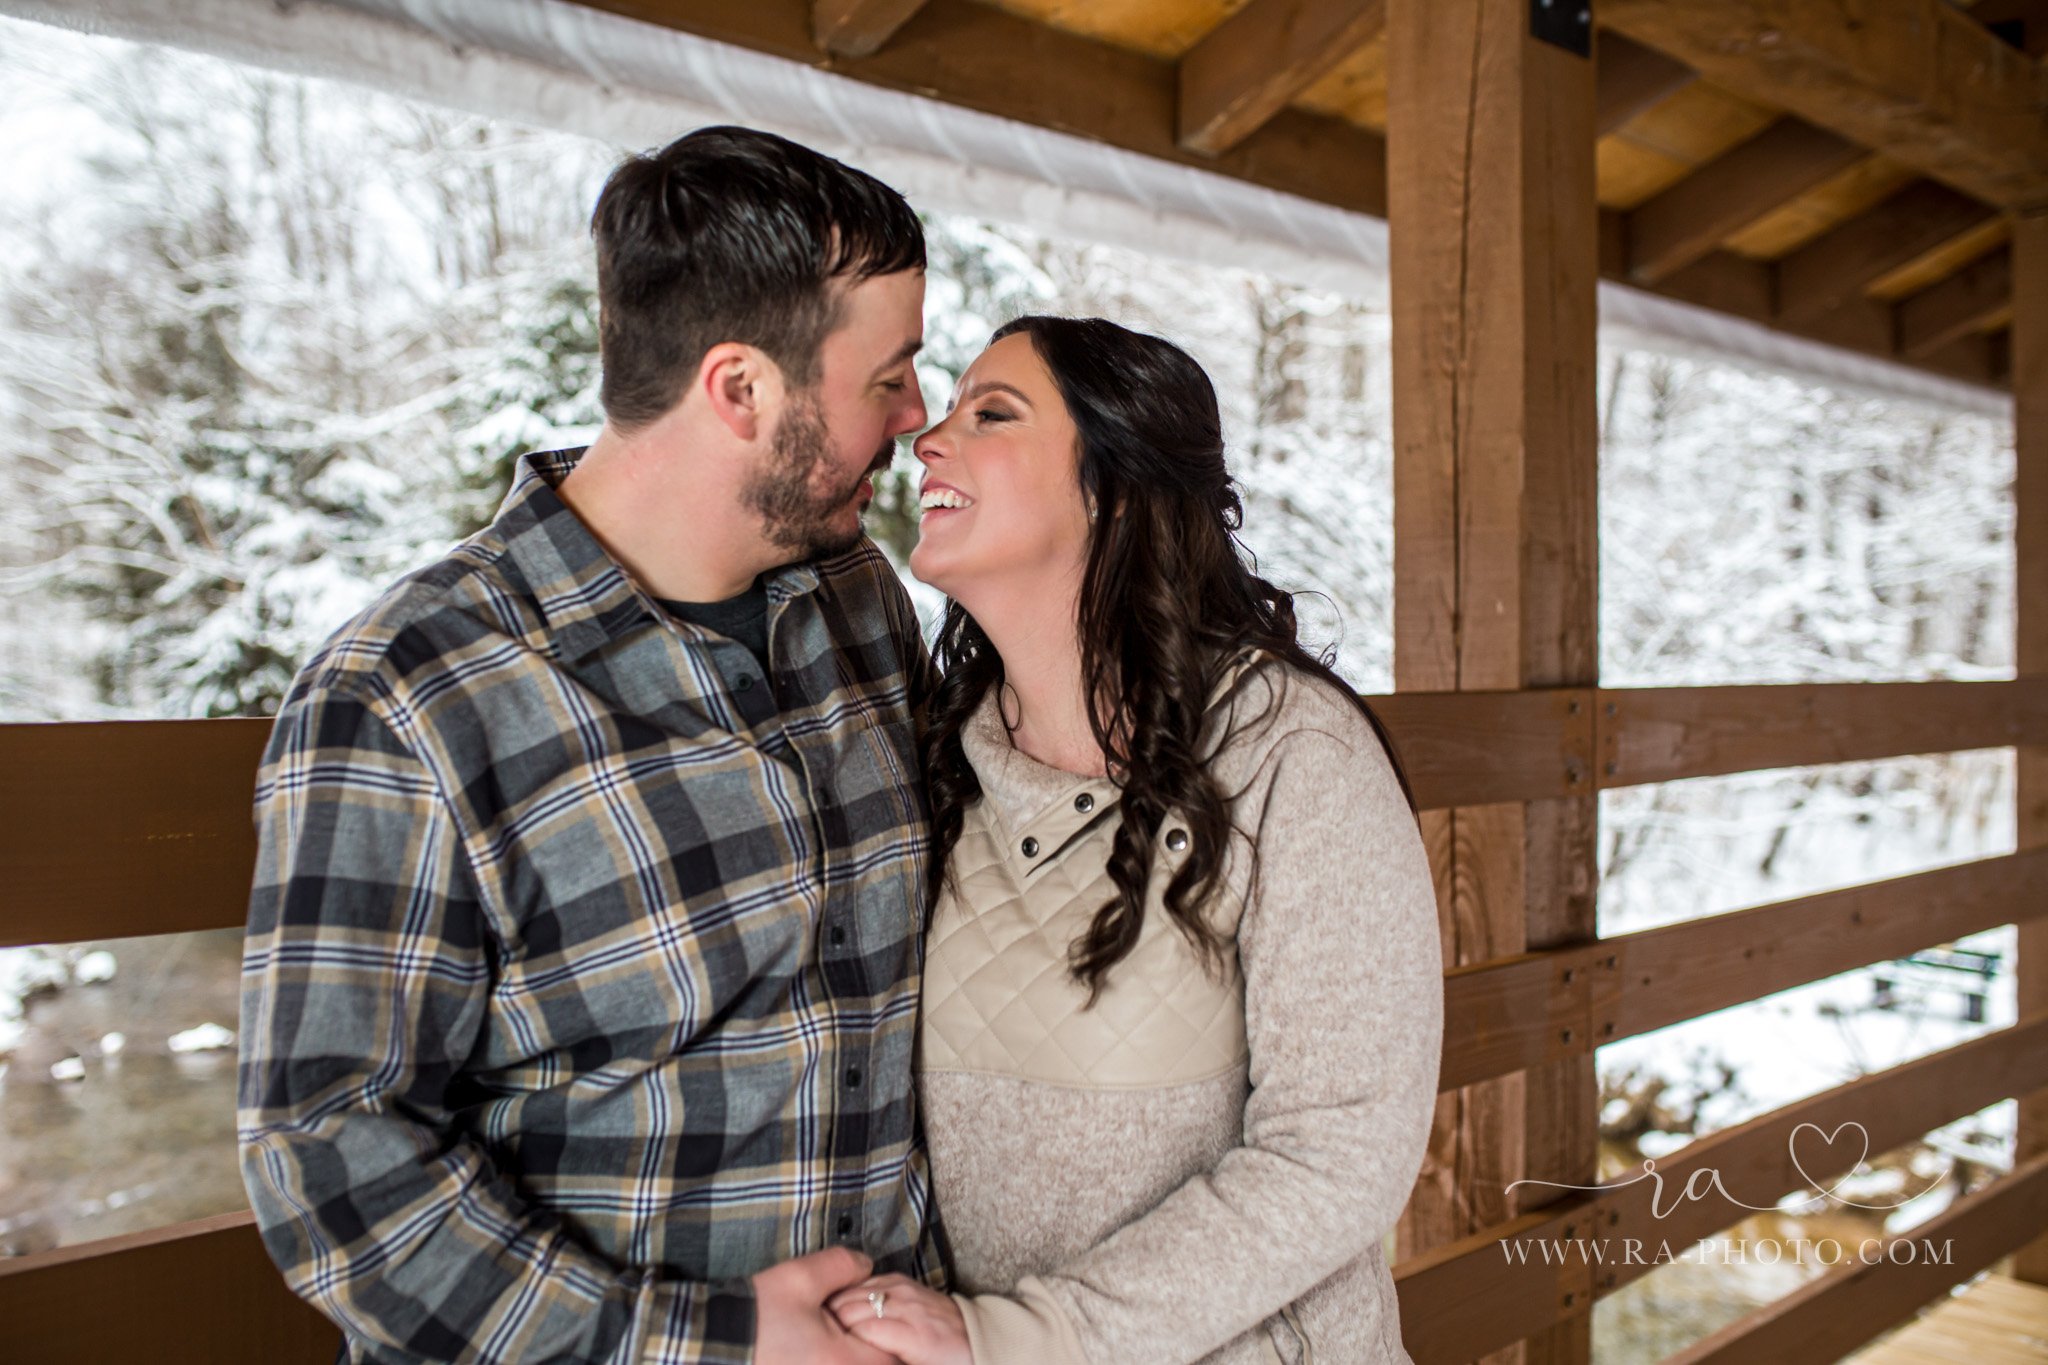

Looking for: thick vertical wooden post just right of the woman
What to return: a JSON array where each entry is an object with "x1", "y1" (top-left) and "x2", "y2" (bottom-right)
[{"x1": 1386, "y1": 0, "x2": 1599, "y2": 1363}]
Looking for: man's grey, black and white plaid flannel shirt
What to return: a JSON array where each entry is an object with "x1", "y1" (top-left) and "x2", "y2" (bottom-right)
[{"x1": 238, "y1": 450, "x2": 946, "y2": 1365}]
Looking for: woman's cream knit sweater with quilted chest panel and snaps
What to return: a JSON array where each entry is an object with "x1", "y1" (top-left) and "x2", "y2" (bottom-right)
[{"x1": 920, "y1": 657, "x2": 1444, "y2": 1365}]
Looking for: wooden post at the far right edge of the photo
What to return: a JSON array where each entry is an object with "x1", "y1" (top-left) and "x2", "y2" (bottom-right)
[{"x1": 2013, "y1": 213, "x2": 2048, "y2": 1285}]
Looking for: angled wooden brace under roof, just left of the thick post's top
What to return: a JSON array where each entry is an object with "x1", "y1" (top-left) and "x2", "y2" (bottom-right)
[{"x1": 1180, "y1": 0, "x2": 1386, "y2": 156}]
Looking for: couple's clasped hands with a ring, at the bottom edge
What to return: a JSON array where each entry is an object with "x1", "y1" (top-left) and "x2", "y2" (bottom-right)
[{"x1": 754, "y1": 1246, "x2": 975, "y2": 1365}]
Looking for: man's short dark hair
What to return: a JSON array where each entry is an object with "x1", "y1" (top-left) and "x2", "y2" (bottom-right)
[{"x1": 590, "y1": 127, "x2": 924, "y2": 430}]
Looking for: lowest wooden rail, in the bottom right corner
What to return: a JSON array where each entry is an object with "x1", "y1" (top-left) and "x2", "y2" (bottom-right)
[{"x1": 1665, "y1": 1152, "x2": 2048, "y2": 1365}]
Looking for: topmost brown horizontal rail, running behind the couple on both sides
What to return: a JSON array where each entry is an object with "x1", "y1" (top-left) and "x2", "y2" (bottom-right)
[{"x1": 0, "y1": 677, "x2": 2048, "y2": 945}]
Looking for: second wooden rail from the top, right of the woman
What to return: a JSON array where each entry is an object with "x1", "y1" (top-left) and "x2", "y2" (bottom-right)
[{"x1": 1438, "y1": 847, "x2": 2048, "y2": 1091}]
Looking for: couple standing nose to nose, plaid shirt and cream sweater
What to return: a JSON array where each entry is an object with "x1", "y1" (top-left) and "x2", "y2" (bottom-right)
[{"x1": 238, "y1": 129, "x2": 1442, "y2": 1365}]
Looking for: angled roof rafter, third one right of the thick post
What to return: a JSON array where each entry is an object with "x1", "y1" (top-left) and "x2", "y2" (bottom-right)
[{"x1": 1778, "y1": 180, "x2": 1997, "y2": 321}]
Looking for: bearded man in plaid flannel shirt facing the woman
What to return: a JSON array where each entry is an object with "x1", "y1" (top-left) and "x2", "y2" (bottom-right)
[{"x1": 238, "y1": 129, "x2": 946, "y2": 1365}]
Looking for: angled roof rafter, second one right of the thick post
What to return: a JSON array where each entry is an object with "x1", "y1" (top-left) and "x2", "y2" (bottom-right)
[{"x1": 1628, "y1": 119, "x2": 1870, "y2": 282}]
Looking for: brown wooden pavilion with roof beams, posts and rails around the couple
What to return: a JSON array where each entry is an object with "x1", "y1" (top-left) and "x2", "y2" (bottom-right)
[{"x1": 0, "y1": 0, "x2": 2048, "y2": 1365}]
